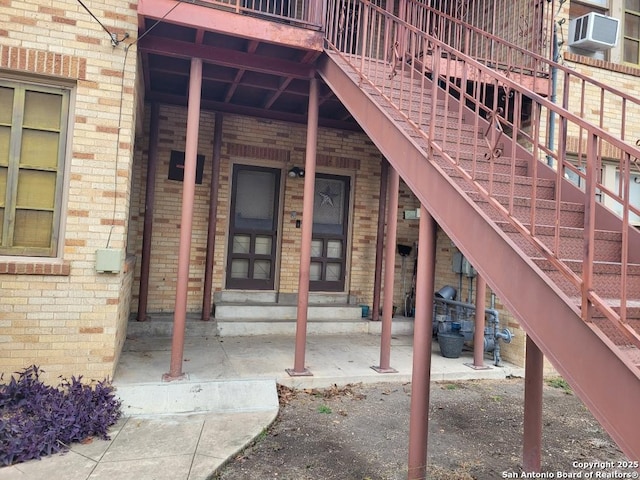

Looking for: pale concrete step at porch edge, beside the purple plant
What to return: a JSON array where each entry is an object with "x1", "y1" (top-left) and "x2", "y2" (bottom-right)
[{"x1": 114, "y1": 378, "x2": 278, "y2": 415}]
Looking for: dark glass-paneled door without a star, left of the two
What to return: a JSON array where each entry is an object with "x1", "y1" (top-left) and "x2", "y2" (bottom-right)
[{"x1": 226, "y1": 165, "x2": 280, "y2": 290}]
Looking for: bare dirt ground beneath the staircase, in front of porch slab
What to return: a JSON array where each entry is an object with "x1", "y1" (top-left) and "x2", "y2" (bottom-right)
[{"x1": 214, "y1": 378, "x2": 637, "y2": 480}]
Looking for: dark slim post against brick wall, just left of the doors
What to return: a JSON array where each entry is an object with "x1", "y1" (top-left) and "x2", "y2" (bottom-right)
[{"x1": 202, "y1": 113, "x2": 224, "y2": 321}]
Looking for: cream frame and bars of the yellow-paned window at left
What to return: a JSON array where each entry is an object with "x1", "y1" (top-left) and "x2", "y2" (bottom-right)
[{"x1": 0, "y1": 78, "x2": 72, "y2": 258}]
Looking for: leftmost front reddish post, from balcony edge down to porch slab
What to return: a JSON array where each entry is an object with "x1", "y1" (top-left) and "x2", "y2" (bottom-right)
[{"x1": 163, "y1": 58, "x2": 202, "y2": 381}]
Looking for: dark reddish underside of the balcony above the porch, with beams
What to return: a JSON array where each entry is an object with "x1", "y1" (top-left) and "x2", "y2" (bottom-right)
[{"x1": 138, "y1": 9, "x2": 360, "y2": 130}]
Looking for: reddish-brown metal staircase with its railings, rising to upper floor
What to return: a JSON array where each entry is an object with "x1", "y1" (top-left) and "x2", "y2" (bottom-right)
[{"x1": 318, "y1": 0, "x2": 640, "y2": 459}]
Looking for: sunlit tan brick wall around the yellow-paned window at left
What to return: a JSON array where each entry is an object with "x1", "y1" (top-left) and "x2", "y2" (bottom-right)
[{"x1": 0, "y1": 0, "x2": 137, "y2": 381}]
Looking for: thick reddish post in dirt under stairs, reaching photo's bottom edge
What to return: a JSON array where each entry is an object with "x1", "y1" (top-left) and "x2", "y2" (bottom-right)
[{"x1": 407, "y1": 205, "x2": 436, "y2": 480}]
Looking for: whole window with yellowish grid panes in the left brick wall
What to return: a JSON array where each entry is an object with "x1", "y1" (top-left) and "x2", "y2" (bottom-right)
[{"x1": 0, "y1": 80, "x2": 69, "y2": 256}]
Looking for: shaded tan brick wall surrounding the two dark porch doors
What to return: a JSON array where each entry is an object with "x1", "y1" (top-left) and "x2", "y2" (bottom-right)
[{"x1": 130, "y1": 105, "x2": 380, "y2": 312}]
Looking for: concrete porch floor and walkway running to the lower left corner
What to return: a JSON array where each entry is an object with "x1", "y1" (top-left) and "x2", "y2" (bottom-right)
[{"x1": 0, "y1": 334, "x2": 524, "y2": 480}]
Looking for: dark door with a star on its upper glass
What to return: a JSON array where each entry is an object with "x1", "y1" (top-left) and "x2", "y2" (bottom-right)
[{"x1": 309, "y1": 174, "x2": 351, "y2": 292}]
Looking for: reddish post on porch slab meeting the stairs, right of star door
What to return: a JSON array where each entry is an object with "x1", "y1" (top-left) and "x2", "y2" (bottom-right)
[{"x1": 371, "y1": 163, "x2": 400, "y2": 373}]
